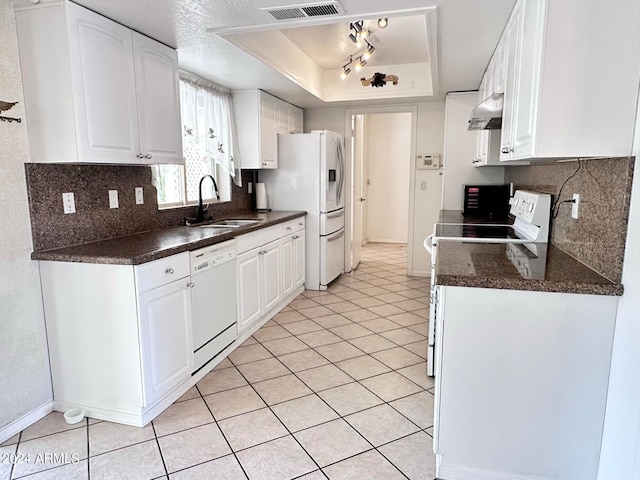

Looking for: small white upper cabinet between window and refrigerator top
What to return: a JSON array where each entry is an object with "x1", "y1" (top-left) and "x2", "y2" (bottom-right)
[{"x1": 233, "y1": 90, "x2": 302, "y2": 168}]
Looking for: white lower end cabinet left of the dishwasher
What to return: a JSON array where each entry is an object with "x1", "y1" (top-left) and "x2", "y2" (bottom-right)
[{"x1": 40, "y1": 252, "x2": 193, "y2": 426}]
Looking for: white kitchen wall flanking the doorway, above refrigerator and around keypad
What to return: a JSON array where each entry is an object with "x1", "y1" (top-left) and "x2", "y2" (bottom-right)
[{"x1": 304, "y1": 102, "x2": 445, "y2": 275}]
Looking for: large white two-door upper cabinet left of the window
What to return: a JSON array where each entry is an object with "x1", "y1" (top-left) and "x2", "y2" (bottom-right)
[{"x1": 16, "y1": 1, "x2": 183, "y2": 164}]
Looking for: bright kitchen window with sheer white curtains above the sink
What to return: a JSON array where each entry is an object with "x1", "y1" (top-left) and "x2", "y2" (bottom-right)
[{"x1": 152, "y1": 73, "x2": 241, "y2": 208}]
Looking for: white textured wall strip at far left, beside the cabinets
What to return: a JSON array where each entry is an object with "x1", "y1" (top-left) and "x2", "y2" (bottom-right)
[{"x1": 0, "y1": 2, "x2": 52, "y2": 443}]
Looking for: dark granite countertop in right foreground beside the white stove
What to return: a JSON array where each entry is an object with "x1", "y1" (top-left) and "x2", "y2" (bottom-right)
[{"x1": 436, "y1": 240, "x2": 623, "y2": 296}]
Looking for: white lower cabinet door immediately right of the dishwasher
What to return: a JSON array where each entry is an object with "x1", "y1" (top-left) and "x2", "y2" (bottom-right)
[{"x1": 236, "y1": 248, "x2": 262, "y2": 334}]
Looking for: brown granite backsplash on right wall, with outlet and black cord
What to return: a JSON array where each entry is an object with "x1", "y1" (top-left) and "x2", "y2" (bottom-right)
[{"x1": 505, "y1": 157, "x2": 634, "y2": 282}]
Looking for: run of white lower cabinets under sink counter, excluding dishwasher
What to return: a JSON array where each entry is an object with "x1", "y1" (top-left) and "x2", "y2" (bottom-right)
[{"x1": 40, "y1": 218, "x2": 305, "y2": 426}]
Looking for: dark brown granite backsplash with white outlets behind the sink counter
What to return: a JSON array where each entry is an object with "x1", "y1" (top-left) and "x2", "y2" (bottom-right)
[{"x1": 25, "y1": 163, "x2": 252, "y2": 251}]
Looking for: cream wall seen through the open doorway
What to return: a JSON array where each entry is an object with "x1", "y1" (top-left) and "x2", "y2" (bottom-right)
[{"x1": 364, "y1": 113, "x2": 411, "y2": 243}]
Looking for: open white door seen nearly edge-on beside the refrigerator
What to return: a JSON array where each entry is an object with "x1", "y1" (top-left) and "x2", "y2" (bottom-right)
[{"x1": 351, "y1": 115, "x2": 367, "y2": 269}]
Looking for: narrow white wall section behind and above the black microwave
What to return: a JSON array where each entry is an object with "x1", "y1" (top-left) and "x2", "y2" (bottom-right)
[{"x1": 442, "y1": 92, "x2": 504, "y2": 210}]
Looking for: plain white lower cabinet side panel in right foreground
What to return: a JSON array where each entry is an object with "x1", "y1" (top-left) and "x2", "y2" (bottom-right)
[{"x1": 434, "y1": 286, "x2": 618, "y2": 480}]
